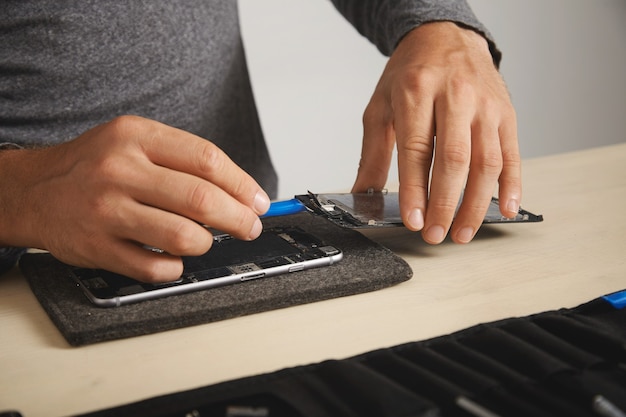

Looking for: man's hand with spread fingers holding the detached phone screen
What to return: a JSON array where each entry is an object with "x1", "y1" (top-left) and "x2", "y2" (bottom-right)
[{"x1": 353, "y1": 22, "x2": 521, "y2": 244}]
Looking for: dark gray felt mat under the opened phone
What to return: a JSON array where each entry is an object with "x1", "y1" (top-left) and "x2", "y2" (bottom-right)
[{"x1": 19, "y1": 213, "x2": 412, "y2": 346}]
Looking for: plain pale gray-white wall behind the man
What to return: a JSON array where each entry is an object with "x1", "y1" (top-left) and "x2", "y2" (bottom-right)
[{"x1": 239, "y1": 0, "x2": 626, "y2": 198}]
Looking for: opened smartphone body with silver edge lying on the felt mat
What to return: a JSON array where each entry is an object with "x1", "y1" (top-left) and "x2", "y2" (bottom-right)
[{"x1": 72, "y1": 227, "x2": 343, "y2": 307}]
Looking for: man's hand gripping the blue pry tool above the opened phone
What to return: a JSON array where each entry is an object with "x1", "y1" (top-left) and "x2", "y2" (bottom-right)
[{"x1": 0, "y1": 116, "x2": 269, "y2": 282}]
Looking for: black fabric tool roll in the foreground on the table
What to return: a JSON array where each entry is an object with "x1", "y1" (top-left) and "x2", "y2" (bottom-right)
[{"x1": 77, "y1": 292, "x2": 626, "y2": 417}]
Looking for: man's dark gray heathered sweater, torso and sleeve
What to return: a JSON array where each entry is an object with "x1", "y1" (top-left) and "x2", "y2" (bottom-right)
[{"x1": 0, "y1": 0, "x2": 499, "y2": 272}]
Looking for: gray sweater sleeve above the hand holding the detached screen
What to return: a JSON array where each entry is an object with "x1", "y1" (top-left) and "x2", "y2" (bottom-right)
[{"x1": 331, "y1": 0, "x2": 502, "y2": 66}]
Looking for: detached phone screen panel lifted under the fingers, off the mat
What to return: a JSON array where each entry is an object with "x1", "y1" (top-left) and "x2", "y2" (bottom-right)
[{"x1": 295, "y1": 190, "x2": 543, "y2": 229}]
